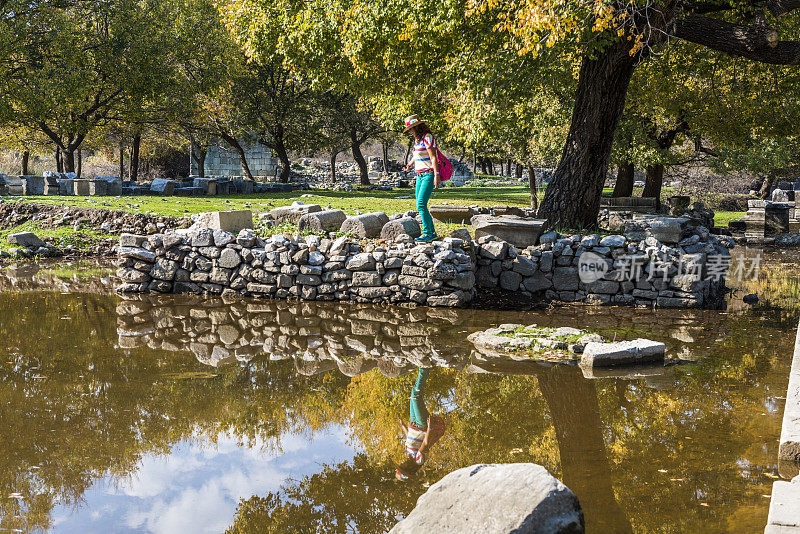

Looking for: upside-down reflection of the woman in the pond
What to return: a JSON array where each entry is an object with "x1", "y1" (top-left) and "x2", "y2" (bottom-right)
[{"x1": 395, "y1": 367, "x2": 444, "y2": 480}]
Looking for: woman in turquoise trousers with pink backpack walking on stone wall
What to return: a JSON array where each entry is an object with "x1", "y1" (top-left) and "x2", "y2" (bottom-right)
[{"x1": 403, "y1": 115, "x2": 440, "y2": 242}]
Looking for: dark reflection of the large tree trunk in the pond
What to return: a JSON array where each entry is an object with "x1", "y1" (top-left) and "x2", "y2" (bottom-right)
[{"x1": 537, "y1": 367, "x2": 633, "y2": 533}]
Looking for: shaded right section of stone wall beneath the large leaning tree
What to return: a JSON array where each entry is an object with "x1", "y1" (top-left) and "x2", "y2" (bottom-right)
[{"x1": 475, "y1": 227, "x2": 733, "y2": 308}]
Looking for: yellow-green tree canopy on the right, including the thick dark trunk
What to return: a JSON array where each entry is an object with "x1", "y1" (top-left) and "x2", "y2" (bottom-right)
[{"x1": 223, "y1": 0, "x2": 800, "y2": 226}]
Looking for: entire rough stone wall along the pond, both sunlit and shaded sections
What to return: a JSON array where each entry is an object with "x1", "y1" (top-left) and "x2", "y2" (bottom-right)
[{"x1": 117, "y1": 219, "x2": 732, "y2": 308}]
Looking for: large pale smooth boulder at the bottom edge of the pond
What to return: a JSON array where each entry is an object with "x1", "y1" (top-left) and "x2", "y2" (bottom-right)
[{"x1": 390, "y1": 463, "x2": 584, "y2": 534}]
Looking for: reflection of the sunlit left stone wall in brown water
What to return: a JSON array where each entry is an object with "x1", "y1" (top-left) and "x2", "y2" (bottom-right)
[{"x1": 117, "y1": 296, "x2": 469, "y2": 376}]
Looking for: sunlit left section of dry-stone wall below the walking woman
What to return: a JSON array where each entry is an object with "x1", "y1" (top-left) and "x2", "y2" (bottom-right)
[{"x1": 117, "y1": 232, "x2": 475, "y2": 306}]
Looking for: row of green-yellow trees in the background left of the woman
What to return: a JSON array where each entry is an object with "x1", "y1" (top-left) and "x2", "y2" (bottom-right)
[{"x1": 0, "y1": 0, "x2": 393, "y2": 181}]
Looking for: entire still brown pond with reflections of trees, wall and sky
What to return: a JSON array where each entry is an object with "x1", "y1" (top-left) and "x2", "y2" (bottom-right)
[{"x1": 0, "y1": 254, "x2": 798, "y2": 533}]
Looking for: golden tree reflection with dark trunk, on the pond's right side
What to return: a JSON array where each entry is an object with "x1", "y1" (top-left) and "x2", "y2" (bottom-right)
[{"x1": 225, "y1": 308, "x2": 796, "y2": 532}]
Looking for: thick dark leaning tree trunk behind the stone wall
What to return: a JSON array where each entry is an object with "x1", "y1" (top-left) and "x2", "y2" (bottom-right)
[{"x1": 539, "y1": 40, "x2": 639, "y2": 228}]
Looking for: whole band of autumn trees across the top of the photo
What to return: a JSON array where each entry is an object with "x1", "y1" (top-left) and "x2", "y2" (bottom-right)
[{"x1": 0, "y1": 0, "x2": 800, "y2": 226}]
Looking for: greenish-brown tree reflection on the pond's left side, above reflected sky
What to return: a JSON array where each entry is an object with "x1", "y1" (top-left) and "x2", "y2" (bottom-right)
[{"x1": 0, "y1": 293, "x2": 347, "y2": 531}]
